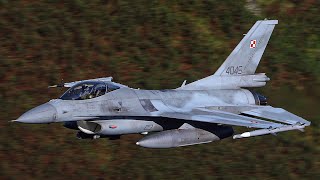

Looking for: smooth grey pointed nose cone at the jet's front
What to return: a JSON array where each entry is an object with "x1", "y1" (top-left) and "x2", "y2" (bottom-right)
[{"x1": 15, "y1": 103, "x2": 57, "y2": 123}]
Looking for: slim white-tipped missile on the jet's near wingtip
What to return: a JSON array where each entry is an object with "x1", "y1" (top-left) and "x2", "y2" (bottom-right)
[{"x1": 233, "y1": 124, "x2": 306, "y2": 139}]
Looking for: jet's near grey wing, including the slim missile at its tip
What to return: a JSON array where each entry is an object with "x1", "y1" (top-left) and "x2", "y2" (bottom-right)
[{"x1": 161, "y1": 106, "x2": 311, "y2": 139}]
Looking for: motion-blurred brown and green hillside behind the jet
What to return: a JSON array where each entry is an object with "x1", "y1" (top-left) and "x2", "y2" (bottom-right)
[{"x1": 0, "y1": 0, "x2": 320, "y2": 179}]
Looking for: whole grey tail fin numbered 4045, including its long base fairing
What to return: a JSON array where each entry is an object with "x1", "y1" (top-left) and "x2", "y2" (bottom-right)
[{"x1": 178, "y1": 20, "x2": 278, "y2": 90}]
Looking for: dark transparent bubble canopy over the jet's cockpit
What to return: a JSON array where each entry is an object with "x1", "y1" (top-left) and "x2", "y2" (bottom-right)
[{"x1": 60, "y1": 81, "x2": 120, "y2": 100}]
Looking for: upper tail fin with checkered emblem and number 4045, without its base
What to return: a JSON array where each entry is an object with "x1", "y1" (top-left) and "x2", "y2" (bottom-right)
[{"x1": 214, "y1": 20, "x2": 278, "y2": 76}]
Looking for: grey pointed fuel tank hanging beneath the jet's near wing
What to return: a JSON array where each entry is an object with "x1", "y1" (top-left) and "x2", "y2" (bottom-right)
[{"x1": 136, "y1": 128, "x2": 233, "y2": 148}]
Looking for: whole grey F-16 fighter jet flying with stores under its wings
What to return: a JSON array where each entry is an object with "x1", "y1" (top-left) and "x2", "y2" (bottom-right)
[{"x1": 14, "y1": 20, "x2": 310, "y2": 148}]
